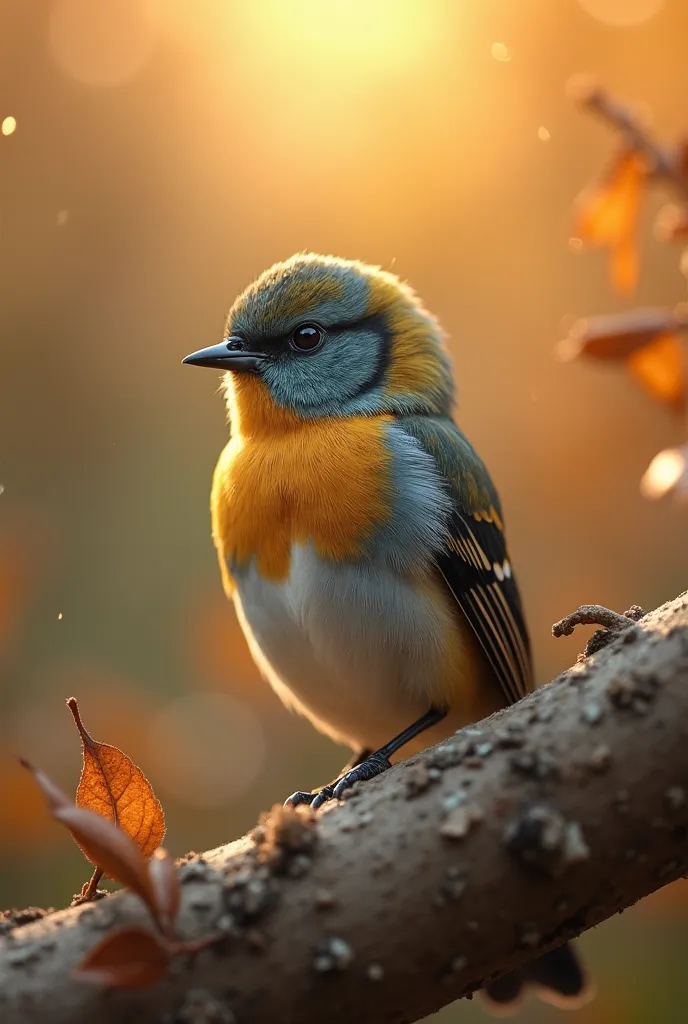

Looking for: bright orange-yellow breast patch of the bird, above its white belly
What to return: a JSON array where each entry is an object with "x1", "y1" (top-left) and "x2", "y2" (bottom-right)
[{"x1": 211, "y1": 382, "x2": 391, "y2": 593}]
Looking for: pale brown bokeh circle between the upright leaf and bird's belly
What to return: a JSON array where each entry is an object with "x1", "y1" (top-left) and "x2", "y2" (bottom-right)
[{"x1": 145, "y1": 693, "x2": 265, "y2": 807}]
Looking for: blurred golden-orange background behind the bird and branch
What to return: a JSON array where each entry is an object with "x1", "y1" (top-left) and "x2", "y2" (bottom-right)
[{"x1": 0, "y1": 0, "x2": 688, "y2": 1024}]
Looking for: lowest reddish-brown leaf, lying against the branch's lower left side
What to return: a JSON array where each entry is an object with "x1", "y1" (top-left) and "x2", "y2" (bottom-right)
[{"x1": 73, "y1": 925, "x2": 171, "y2": 988}]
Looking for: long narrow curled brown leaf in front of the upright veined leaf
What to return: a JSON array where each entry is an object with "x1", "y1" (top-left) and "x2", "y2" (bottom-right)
[{"x1": 22, "y1": 761, "x2": 158, "y2": 919}]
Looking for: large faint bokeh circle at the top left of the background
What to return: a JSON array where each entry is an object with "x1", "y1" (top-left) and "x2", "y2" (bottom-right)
[{"x1": 49, "y1": 0, "x2": 157, "y2": 86}]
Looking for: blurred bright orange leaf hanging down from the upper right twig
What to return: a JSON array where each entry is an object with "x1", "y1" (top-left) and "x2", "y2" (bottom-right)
[{"x1": 573, "y1": 147, "x2": 648, "y2": 293}]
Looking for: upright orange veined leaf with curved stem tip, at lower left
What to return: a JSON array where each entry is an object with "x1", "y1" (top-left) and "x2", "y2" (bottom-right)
[{"x1": 67, "y1": 697, "x2": 165, "y2": 859}]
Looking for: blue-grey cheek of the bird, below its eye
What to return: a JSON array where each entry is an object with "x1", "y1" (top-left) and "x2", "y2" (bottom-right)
[{"x1": 263, "y1": 329, "x2": 384, "y2": 416}]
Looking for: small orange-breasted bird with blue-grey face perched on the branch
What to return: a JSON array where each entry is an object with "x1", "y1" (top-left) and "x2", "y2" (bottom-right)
[{"x1": 183, "y1": 253, "x2": 586, "y2": 1008}]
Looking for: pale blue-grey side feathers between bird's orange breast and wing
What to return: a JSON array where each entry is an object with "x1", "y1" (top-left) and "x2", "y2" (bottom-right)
[{"x1": 369, "y1": 424, "x2": 452, "y2": 572}]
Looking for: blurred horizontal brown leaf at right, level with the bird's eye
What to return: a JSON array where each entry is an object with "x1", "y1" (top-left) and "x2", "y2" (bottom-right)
[{"x1": 557, "y1": 307, "x2": 682, "y2": 361}]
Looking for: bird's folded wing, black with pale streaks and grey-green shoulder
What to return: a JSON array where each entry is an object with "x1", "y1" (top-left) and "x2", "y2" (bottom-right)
[{"x1": 400, "y1": 416, "x2": 532, "y2": 703}]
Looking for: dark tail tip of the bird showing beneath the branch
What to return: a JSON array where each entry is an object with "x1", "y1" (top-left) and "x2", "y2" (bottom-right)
[{"x1": 482, "y1": 942, "x2": 594, "y2": 1017}]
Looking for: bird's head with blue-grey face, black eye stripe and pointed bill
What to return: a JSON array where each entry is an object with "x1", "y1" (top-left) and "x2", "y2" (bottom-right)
[{"x1": 184, "y1": 253, "x2": 454, "y2": 432}]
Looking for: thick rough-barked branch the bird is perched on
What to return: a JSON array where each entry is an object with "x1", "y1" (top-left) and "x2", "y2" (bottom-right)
[{"x1": 0, "y1": 595, "x2": 688, "y2": 1024}]
